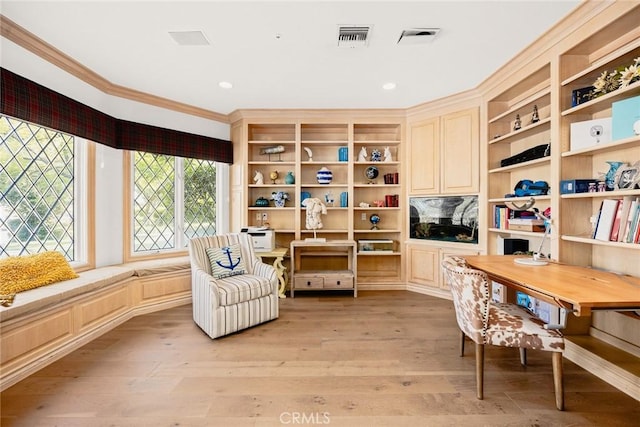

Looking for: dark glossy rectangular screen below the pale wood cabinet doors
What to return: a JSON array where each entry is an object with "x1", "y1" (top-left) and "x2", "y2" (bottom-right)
[{"x1": 409, "y1": 196, "x2": 478, "y2": 243}]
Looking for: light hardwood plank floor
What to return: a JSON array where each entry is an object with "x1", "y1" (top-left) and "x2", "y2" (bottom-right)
[{"x1": 1, "y1": 291, "x2": 640, "y2": 427}]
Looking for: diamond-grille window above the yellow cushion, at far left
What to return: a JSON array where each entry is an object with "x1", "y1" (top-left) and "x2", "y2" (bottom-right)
[{"x1": 0, "y1": 116, "x2": 76, "y2": 261}]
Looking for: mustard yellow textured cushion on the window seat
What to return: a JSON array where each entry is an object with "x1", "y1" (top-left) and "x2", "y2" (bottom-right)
[{"x1": 0, "y1": 251, "x2": 78, "y2": 307}]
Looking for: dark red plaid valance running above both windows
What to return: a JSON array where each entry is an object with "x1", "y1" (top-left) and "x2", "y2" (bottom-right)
[{"x1": 0, "y1": 68, "x2": 233, "y2": 163}]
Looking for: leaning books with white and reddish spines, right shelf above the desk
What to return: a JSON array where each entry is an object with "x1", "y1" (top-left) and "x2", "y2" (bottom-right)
[{"x1": 592, "y1": 196, "x2": 640, "y2": 243}]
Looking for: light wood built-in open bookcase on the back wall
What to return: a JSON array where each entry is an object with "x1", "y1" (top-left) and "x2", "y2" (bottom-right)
[{"x1": 231, "y1": 110, "x2": 405, "y2": 289}]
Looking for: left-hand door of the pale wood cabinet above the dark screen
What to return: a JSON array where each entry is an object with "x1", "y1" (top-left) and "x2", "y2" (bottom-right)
[{"x1": 407, "y1": 117, "x2": 440, "y2": 194}]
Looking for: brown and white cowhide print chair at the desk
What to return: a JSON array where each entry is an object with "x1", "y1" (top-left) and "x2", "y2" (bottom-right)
[{"x1": 442, "y1": 256, "x2": 564, "y2": 411}]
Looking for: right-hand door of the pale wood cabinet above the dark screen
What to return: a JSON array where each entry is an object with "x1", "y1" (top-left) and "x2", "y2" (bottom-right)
[{"x1": 442, "y1": 108, "x2": 480, "y2": 194}]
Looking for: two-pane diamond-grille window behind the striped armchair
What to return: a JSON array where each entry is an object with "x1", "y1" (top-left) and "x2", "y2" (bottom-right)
[{"x1": 133, "y1": 152, "x2": 216, "y2": 253}]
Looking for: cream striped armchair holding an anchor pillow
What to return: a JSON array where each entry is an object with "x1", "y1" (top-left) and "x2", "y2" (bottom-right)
[{"x1": 189, "y1": 233, "x2": 278, "y2": 339}]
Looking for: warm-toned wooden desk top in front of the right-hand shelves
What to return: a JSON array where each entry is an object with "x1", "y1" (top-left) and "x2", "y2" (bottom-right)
[{"x1": 464, "y1": 255, "x2": 640, "y2": 316}]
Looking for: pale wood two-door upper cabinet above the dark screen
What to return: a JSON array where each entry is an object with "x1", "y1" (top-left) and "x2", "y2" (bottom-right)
[{"x1": 407, "y1": 108, "x2": 480, "y2": 194}]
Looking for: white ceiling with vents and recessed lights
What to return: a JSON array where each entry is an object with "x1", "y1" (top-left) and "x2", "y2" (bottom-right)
[{"x1": 1, "y1": 0, "x2": 580, "y2": 114}]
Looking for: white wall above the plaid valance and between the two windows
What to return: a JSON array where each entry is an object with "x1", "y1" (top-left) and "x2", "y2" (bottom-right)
[{"x1": 0, "y1": 38, "x2": 230, "y2": 267}]
